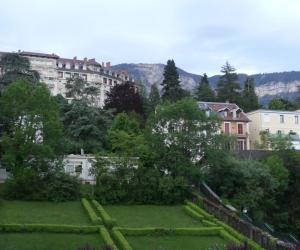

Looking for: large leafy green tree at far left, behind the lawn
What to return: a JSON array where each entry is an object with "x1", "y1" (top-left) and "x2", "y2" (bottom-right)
[{"x1": 0, "y1": 80, "x2": 79, "y2": 200}]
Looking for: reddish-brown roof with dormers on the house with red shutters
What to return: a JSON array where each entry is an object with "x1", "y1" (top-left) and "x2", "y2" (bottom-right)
[{"x1": 198, "y1": 102, "x2": 250, "y2": 122}]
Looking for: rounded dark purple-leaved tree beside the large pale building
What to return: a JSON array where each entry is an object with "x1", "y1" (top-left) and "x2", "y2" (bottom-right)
[{"x1": 104, "y1": 82, "x2": 143, "y2": 114}]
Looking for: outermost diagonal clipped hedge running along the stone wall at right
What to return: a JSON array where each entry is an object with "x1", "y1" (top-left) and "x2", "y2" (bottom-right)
[{"x1": 186, "y1": 201, "x2": 263, "y2": 250}]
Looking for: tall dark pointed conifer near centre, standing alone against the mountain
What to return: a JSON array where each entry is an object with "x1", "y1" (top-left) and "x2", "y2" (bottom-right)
[{"x1": 161, "y1": 60, "x2": 184, "y2": 102}]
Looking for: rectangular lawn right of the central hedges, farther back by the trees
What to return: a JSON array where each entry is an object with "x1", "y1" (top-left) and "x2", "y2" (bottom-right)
[{"x1": 104, "y1": 205, "x2": 202, "y2": 228}]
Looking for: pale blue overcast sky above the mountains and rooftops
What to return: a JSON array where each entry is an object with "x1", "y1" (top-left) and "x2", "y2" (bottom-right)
[{"x1": 0, "y1": 0, "x2": 300, "y2": 75}]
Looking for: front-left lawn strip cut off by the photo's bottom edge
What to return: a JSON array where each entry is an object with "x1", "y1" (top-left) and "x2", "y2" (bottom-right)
[{"x1": 0, "y1": 233, "x2": 104, "y2": 250}]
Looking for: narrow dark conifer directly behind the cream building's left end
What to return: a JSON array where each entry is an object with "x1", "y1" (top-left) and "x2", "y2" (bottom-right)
[{"x1": 241, "y1": 77, "x2": 260, "y2": 112}]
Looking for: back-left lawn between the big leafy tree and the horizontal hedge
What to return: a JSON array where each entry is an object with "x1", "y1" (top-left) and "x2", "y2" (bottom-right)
[{"x1": 0, "y1": 201, "x2": 90, "y2": 225}]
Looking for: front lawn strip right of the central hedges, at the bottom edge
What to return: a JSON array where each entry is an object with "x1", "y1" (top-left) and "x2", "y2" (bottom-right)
[{"x1": 126, "y1": 236, "x2": 226, "y2": 250}]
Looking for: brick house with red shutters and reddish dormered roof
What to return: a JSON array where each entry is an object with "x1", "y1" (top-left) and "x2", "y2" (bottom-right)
[{"x1": 198, "y1": 102, "x2": 250, "y2": 150}]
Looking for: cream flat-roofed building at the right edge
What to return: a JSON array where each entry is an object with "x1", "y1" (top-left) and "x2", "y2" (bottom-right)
[{"x1": 247, "y1": 109, "x2": 300, "y2": 150}]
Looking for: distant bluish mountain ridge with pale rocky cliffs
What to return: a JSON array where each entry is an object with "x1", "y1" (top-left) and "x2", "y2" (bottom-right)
[{"x1": 113, "y1": 63, "x2": 300, "y2": 104}]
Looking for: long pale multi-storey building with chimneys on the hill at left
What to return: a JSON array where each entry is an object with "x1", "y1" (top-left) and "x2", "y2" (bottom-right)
[{"x1": 0, "y1": 51, "x2": 133, "y2": 107}]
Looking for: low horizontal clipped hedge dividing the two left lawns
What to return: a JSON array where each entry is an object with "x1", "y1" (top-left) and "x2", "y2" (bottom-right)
[{"x1": 0, "y1": 224, "x2": 99, "y2": 233}]
